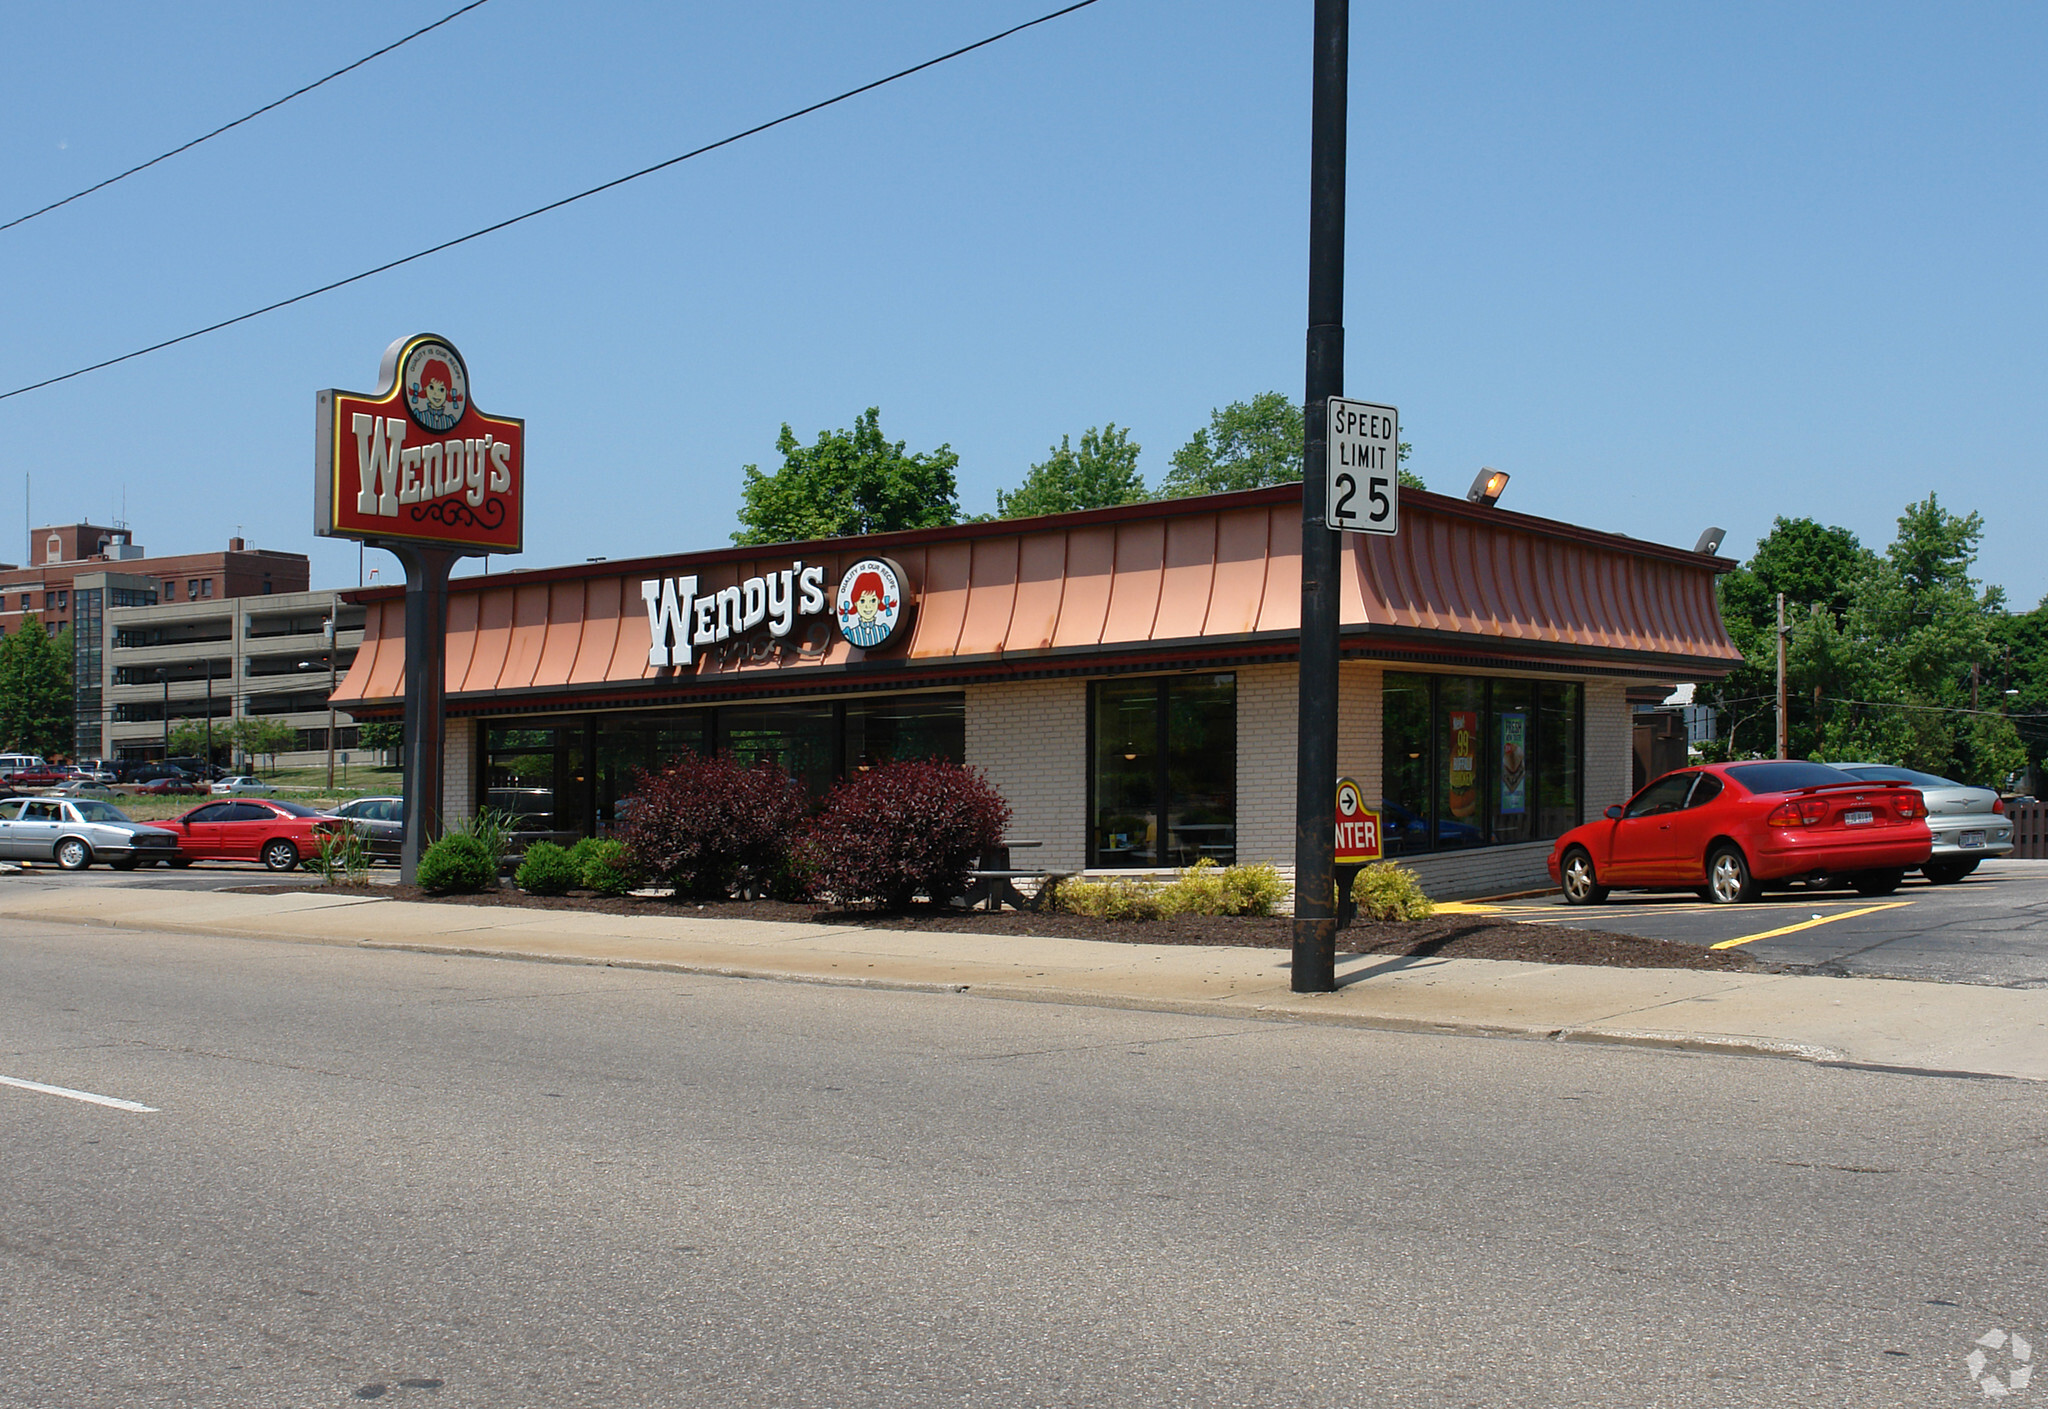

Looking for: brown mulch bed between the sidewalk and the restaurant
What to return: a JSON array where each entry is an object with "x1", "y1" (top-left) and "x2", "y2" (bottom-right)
[{"x1": 238, "y1": 885, "x2": 1763, "y2": 973}]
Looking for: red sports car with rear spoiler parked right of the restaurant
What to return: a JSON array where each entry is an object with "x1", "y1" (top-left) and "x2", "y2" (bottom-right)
[{"x1": 1550, "y1": 760, "x2": 1933, "y2": 905}]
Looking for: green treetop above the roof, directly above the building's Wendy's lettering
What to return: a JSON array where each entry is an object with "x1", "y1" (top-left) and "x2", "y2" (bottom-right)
[{"x1": 733, "y1": 405, "x2": 961, "y2": 545}]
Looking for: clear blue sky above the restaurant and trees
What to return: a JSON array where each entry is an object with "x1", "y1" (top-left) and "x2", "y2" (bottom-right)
[{"x1": 0, "y1": 0, "x2": 2048, "y2": 606}]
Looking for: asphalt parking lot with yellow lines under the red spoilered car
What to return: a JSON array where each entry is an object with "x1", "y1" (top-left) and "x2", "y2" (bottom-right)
[{"x1": 1501, "y1": 860, "x2": 2048, "y2": 987}]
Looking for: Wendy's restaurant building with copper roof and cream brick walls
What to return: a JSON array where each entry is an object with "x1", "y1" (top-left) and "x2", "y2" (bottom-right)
[{"x1": 336, "y1": 483, "x2": 1741, "y2": 897}]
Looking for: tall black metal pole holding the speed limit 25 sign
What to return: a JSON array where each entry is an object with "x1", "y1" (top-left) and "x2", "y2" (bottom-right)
[{"x1": 1292, "y1": 0, "x2": 1352, "y2": 993}]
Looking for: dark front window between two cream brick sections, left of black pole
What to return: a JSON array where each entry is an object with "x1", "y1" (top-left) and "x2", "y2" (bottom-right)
[{"x1": 1090, "y1": 676, "x2": 1237, "y2": 866}]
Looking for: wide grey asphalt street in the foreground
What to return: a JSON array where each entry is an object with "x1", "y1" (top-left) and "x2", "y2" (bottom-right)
[{"x1": 0, "y1": 922, "x2": 2048, "y2": 1409}]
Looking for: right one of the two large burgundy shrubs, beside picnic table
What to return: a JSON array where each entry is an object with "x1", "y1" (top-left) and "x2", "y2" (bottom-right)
[{"x1": 801, "y1": 758, "x2": 1010, "y2": 909}]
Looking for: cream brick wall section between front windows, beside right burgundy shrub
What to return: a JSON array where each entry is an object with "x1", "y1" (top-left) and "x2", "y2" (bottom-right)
[{"x1": 967, "y1": 680, "x2": 1087, "y2": 870}]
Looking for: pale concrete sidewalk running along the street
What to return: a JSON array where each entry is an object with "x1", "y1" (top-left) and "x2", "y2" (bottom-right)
[{"x1": 0, "y1": 887, "x2": 2048, "y2": 1081}]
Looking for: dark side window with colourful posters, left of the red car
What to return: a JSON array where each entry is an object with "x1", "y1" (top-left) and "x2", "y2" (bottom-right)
[{"x1": 1380, "y1": 672, "x2": 1585, "y2": 856}]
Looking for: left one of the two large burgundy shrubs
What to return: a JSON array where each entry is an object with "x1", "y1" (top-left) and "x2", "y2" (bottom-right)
[{"x1": 621, "y1": 756, "x2": 805, "y2": 899}]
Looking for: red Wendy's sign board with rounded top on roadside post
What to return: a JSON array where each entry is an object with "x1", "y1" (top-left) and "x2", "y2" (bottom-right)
[{"x1": 313, "y1": 334, "x2": 526, "y2": 553}]
